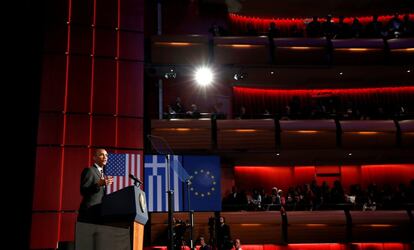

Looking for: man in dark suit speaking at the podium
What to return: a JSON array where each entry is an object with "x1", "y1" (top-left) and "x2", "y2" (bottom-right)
[{"x1": 78, "y1": 149, "x2": 113, "y2": 223}]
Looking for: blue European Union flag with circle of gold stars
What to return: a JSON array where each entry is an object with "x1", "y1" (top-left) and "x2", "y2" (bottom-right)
[{"x1": 182, "y1": 156, "x2": 221, "y2": 211}]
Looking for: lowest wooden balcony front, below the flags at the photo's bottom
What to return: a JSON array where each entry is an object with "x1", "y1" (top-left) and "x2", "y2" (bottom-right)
[{"x1": 150, "y1": 209, "x2": 414, "y2": 245}]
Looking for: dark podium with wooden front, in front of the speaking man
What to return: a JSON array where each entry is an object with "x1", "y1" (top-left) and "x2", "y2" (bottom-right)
[{"x1": 75, "y1": 186, "x2": 148, "y2": 250}]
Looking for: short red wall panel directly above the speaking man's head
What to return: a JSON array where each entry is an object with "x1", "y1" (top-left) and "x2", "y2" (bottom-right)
[{"x1": 92, "y1": 116, "x2": 115, "y2": 146}]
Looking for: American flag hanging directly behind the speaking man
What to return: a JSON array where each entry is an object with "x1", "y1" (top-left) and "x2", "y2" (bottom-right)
[{"x1": 105, "y1": 154, "x2": 142, "y2": 194}]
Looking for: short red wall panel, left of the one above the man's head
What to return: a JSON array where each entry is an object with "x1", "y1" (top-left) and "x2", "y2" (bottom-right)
[{"x1": 65, "y1": 115, "x2": 89, "y2": 145}]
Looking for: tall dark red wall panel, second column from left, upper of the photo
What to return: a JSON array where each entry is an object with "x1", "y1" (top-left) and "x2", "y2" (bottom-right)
[{"x1": 67, "y1": 56, "x2": 91, "y2": 113}]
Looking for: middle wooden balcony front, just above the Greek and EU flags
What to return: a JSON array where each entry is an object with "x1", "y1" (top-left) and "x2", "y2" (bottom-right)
[{"x1": 151, "y1": 119, "x2": 414, "y2": 164}]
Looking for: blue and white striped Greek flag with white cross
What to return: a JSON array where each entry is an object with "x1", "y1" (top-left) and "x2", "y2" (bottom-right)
[{"x1": 144, "y1": 155, "x2": 183, "y2": 212}]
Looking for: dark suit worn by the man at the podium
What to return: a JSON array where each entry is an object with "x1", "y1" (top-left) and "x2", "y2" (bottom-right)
[{"x1": 78, "y1": 165, "x2": 105, "y2": 222}]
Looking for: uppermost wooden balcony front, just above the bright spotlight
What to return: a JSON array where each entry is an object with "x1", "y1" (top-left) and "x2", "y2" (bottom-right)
[{"x1": 150, "y1": 35, "x2": 414, "y2": 65}]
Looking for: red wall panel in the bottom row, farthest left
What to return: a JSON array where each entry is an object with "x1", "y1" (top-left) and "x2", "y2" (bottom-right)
[{"x1": 30, "y1": 213, "x2": 60, "y2": 249}]
